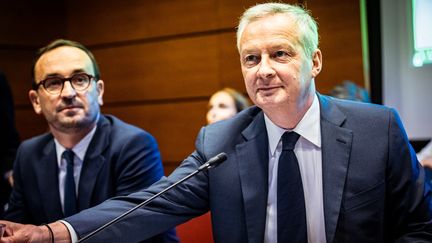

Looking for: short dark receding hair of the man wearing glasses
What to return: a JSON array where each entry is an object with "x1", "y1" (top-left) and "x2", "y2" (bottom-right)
[{"x1": 31, "y1": 39, "x2": 100, "y2": 87}]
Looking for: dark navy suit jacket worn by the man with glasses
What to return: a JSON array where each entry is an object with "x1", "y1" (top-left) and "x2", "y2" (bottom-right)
[{"x1": 5, "y1": 115, "x2": 175, "y2": 242}]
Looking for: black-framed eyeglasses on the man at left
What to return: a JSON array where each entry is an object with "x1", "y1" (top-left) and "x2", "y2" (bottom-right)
[{"x1": 33, "y1": 73, "x2": 94, "y2": 94}]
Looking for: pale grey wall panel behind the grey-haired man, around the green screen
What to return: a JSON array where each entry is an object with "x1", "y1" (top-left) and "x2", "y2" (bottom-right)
[{"x1": 381, "y1": 0, "x2": 432, "y2": 142}]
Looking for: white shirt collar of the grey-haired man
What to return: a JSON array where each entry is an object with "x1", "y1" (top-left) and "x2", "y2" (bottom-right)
[{"x1": 264, "y1": 95, "x2": 321, "y2": 155}]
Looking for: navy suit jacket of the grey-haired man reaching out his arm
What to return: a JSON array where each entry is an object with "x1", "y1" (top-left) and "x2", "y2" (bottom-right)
[{"x1": 66, "y1": 95, "x2": 432, "y2": 243}]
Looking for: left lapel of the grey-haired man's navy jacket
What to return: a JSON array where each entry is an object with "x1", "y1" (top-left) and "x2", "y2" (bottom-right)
[{"x1": 236, "y1": 112, "x2": 268, "y2": 242}]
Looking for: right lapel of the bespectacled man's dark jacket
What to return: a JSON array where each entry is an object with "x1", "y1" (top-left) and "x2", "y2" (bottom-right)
[{"x1": 78, "y1": 115, "x2": 111, "y2": 211}]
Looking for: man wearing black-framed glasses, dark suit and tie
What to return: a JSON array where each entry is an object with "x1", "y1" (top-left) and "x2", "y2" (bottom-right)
[{"x1": 1, "y1": 40, "x2": 176, "y2": 242}]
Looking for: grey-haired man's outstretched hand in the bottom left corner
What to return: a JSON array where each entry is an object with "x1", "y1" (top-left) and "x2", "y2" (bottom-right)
[{"x1": 0, "y1": 221, "x2": 51, "y2": 243}]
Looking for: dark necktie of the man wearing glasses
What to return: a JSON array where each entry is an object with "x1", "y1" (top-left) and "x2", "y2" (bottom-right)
[{"x1": 63, "y1": 150, "x2": 77, "y2": 217}]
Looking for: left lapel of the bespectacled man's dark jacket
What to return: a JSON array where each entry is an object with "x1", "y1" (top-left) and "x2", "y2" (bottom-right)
[{"x1": 33, "y1": 139, "x2": 63, "y2": 223}]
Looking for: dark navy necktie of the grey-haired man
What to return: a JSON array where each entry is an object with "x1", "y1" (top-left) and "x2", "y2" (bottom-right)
[{"x1": 277, "y1": 132, "x2": 307, "y2": 243}]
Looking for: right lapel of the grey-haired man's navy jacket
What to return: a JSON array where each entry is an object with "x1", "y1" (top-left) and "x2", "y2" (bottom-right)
[{"x1": 318, "y1": 95, "x2": 353, "y2": 242}]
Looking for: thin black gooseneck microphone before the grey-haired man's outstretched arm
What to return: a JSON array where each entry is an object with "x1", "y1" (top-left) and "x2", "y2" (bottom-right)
[{"x1": 77, "y1": 152, "x2": 228, "y2": 243}]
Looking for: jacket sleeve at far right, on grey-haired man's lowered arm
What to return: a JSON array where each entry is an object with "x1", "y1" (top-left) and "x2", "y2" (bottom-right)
[{"x1": 386, "y1": 108, "x2": 432, "y2": 242}]
